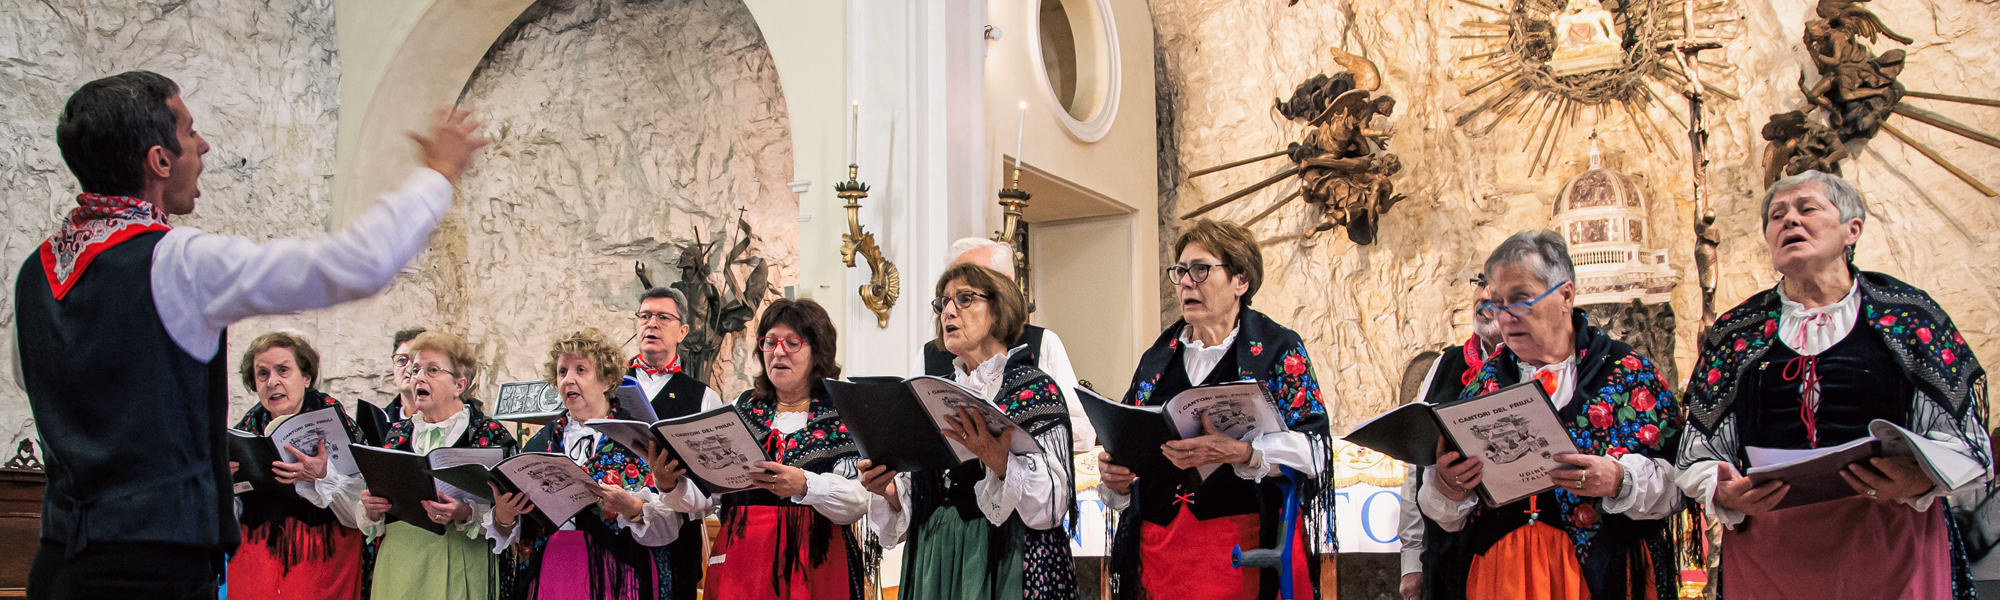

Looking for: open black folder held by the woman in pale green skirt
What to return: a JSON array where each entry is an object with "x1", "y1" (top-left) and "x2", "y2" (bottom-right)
[{"x1": 354, "y1": 446, "x2": 506, "y2": 536}]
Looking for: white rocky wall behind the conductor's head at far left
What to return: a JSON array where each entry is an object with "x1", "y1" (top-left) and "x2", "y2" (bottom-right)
[{"x1": 0, "y1": 0, "x2": 344, "y2": 448}]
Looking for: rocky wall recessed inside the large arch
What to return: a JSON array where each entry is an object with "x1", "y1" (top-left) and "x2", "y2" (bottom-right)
[{"x1": 450, "y1": 0, "x2": 798, "y2": 398}]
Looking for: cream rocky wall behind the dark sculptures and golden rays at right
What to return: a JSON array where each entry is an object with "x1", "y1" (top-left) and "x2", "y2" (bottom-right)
[{"x1": 1152, "y1": 0, "x2": 2000, "y2": 430}]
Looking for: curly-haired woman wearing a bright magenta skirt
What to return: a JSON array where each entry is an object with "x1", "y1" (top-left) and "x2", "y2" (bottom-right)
[{"x1": 486, "y1": 328, "x2": 682, "y2": 600}]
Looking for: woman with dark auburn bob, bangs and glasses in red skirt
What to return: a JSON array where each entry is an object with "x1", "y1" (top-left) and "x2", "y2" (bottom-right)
[{"x1": 648, "y1": 300, "x2": 860, "y2": 600}]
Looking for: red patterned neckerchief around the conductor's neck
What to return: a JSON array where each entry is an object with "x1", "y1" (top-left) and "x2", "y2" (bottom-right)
[{"x1": 38, "y1": 194, "x2": 172, "y2": 300}]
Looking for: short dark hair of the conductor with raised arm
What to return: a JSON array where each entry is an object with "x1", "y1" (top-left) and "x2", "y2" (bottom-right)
[{"x1": 56, "y1": 70, "x2": 180, "y2": 196}]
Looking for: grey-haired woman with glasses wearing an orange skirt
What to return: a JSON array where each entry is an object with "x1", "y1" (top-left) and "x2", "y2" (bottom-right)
[{"x1": 1418, "y1": 230, "x2": 1682, "y2": 600}]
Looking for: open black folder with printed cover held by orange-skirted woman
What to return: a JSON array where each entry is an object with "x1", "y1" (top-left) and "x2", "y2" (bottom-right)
[{"x1": 1346, "y1": 380, "x2": 1576, "y2": 506}]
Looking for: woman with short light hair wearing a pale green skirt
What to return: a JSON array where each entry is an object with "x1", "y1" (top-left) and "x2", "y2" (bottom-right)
[{"x1": 330, "y1": 332, "x2": 516, "y2": 600}]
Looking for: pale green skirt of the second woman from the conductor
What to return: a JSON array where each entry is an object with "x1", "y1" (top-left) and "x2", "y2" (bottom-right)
[{"x1": 374, "y1": 520, "x2": 500, "y2": 600}]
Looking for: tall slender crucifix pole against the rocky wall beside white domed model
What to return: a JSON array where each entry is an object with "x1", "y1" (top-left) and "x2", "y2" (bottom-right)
[{"x1": 1660, "y1": 0, "x2": 1722, "y2": 330}]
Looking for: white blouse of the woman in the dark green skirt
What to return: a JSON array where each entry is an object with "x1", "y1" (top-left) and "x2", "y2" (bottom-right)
[{"x1": 868, "y1": 346, "x2": 1076, "y2": 548}]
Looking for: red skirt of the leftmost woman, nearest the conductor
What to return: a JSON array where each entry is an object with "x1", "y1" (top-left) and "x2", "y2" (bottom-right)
[{"x1": 228, "y1": 526, "x2": 364, "y2": 600}]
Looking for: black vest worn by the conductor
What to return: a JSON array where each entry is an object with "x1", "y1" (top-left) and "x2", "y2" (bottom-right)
[{"x1": 14, "y1": 232, "x2": 242, "y2": 556}]
